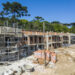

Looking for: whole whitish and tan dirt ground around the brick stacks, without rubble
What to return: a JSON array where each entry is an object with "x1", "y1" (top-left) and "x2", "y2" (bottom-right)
[{"x1": 0, "y1": 45, "x2": 75, "y2": 75}]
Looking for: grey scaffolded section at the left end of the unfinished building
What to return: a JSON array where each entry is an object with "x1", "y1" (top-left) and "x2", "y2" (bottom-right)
[{"x1": 0, "y1": 23, "x2": 27, "y2": 63}]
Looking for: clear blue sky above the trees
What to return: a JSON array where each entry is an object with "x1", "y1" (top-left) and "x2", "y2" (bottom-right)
[{"x1": 0, "y1": 0, "x2": 75, "y2": 23}]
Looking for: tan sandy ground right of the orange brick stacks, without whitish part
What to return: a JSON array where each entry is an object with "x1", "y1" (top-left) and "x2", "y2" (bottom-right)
[{"x1": 23, "y1": 45, "x2": 75, "y2": 75}]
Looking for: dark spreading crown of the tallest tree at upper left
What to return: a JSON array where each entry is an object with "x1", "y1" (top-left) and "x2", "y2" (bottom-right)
[{"x1": 0, "y1": 2, "x2": 30, "y2": 21}]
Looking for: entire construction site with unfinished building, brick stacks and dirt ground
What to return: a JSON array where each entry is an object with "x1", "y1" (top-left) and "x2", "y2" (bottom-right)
[{"x1": 0, "y1": 26, "x2": 75, "y2": 75}]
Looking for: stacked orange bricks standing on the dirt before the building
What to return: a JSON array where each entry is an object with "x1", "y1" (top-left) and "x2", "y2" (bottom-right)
[{"x1": 34, "y1": 50, "x2": 56, "y2": 63}]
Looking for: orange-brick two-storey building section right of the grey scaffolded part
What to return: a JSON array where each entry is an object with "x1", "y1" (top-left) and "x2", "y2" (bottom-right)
[{"x1": 23, "y1": 31, "x2": 75, "y2": 51}]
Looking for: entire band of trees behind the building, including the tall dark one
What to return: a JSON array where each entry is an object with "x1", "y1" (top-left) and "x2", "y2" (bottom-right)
[{"x1": 0, "y1": 2, "x2": 75, "y2": 33}]
